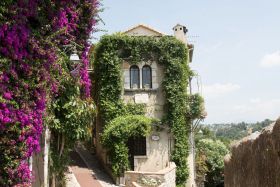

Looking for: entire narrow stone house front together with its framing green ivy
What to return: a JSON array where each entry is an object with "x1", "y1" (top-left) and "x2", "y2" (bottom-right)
[{"x1": 92, "y1": 25, "x2": 203, "y2": 186}]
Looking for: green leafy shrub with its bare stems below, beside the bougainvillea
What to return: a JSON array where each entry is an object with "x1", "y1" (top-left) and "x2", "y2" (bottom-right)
[{"x1": 45, "y1": 77, "x2": 94, "y2": 183}]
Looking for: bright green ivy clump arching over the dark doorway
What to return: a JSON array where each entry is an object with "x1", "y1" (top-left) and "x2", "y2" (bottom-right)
[{"x1": 99, "y1": 101, "x2": 151, "y2": 176}]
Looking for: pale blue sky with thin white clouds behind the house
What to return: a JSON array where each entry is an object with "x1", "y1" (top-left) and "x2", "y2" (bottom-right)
[{"x1": 94, "y1": 0, "x2": 280, "y2": 124}]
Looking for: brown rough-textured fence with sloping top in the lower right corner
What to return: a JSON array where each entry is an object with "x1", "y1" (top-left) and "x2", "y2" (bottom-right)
[{"x1": 225, "y1": 118, "x2": 280, "y2": 187}]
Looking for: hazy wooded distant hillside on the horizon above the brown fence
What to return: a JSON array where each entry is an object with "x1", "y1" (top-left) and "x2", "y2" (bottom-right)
[{"x1": 208, "y1": 119, "x2": 273, "y2": 140}]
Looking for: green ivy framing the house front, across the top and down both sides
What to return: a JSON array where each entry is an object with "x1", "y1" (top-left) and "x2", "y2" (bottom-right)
[{"x1": 93, "y1": 33, "x2": 203, "y2": 185}]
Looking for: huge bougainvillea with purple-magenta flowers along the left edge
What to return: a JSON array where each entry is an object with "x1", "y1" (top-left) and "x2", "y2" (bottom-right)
[{"x1": 0, "y1": 0, "x2": 99, "y2": 186}]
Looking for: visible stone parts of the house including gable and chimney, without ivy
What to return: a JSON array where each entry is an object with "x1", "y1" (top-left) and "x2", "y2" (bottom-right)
[{"x1": 95, "y1": 24, "x2": 196, "y2": 187}]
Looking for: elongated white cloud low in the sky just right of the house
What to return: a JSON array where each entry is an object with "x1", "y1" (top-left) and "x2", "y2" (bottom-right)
[{"x1": 202, "y1": 83, "x2": 240, "y2": 97}]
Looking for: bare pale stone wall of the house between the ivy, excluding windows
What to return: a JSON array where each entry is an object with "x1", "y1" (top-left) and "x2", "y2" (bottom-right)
[{"x1": 122, "y1": 61, "x2": 173, "y2": 172}]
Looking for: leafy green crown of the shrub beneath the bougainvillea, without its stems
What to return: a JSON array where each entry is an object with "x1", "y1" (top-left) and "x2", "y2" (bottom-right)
[{"x1": 48, "y1": 82, "x2": 94, "y2": 143}]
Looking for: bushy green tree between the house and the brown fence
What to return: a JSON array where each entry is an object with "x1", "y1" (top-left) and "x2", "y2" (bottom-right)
[{"x1": 196, "y1": 139, "x2": 229, "y2": 187}]
